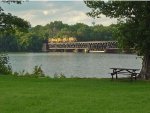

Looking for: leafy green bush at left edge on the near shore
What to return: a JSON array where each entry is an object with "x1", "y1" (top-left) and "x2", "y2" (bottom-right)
[{"x1": 0, "y1": 54, "x2": 12, "y2": 74}]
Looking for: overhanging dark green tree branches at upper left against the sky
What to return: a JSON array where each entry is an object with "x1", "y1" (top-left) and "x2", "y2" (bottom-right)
[{"x1": 0, "y1": 0, "x2": 30, "y2": 34}]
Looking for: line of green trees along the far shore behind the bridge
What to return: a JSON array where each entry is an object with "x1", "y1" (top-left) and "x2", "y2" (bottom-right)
[{"x1": 0, "y1": 21, "x2": 117, "y2": 52}]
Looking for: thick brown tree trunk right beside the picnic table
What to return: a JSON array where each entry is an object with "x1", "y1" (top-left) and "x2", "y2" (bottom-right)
[{"x1": 139, "y1": 54, "x2": 150, "y2": 79}]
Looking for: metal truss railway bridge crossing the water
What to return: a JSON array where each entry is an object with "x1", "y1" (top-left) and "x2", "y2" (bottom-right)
[{"x1": 42, "y1": 41, "x2": 117, "y2": 52}]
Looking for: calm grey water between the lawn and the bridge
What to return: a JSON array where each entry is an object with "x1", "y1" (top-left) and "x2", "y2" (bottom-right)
[{"x1": 9, "y1": 53, "x2": 141, "y2": 78}]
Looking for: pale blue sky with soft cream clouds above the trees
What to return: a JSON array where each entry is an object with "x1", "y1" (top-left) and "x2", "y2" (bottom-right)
[{"x1": 0, "y1": 0, "x2": 116, "y2": 27}]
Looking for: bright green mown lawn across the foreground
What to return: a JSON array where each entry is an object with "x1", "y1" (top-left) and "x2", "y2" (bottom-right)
[{"x1": 0, "y1": 75, "x2": 150, "y2": 113}]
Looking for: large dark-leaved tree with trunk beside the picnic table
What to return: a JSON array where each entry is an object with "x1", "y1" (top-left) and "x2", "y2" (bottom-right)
[{"x1": 85, "y1": 1, "x2": 150, "y2": 79}]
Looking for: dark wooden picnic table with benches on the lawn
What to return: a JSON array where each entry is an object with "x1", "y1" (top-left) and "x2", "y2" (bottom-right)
[{"x1": 110, "y1": 68, "x2": 140, "y2": 80}]
